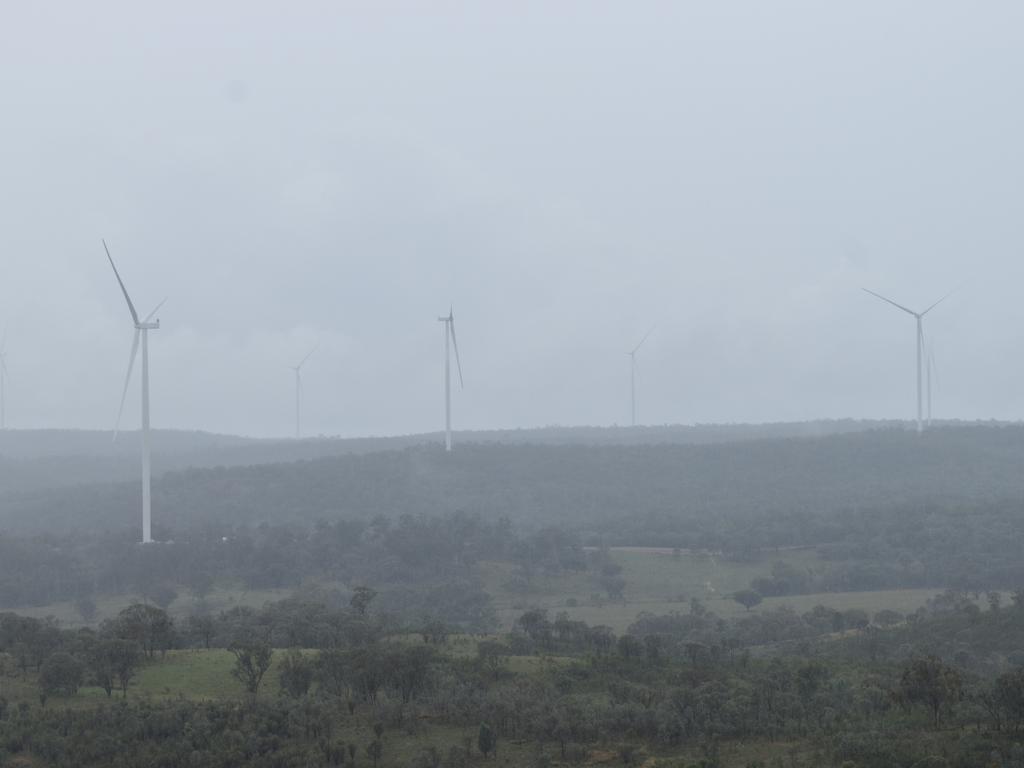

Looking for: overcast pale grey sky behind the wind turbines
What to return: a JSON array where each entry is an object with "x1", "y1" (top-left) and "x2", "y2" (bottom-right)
[{"x1": 0, "y1": 0, "x2": 1024, "y2": 435}]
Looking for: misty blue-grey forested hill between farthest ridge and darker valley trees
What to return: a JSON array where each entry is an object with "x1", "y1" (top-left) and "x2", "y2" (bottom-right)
[{"x1": 6, "y1": 426, "x2": 1024, "y2": 547}]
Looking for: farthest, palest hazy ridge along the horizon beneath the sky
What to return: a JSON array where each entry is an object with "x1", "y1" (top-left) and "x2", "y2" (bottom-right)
[{"x1": 0, "y1": 420, "x2": 893, "y2": 494}]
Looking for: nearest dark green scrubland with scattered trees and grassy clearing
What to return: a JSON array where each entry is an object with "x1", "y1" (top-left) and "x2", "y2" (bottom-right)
[{"x1": 6, "y1": 589, "x2": 1024, "y2": 768}]
